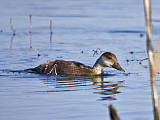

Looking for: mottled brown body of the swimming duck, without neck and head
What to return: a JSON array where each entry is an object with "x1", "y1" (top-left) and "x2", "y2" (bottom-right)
[{"x1": 32, "y1": 60, "x2": 94, "y2": 75}]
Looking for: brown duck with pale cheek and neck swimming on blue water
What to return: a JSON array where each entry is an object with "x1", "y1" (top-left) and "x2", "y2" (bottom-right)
[{"x1": 27, "y1": 52, "x2": 125, "y2": 76}]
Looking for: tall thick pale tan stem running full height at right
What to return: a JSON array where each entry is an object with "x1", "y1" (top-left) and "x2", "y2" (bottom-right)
[{"x1": 144, "y1": 0, "x2": 159, "y2": 120}]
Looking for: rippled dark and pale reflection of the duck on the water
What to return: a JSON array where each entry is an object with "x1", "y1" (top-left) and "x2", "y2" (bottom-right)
[{"x1": 41, "y1": 76, "x2": 124, "y2": 100}]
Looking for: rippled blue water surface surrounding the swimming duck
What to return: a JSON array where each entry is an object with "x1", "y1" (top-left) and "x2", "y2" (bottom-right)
[{"x1": 0, "y1": 0, "x2": 160, "y2": 120}]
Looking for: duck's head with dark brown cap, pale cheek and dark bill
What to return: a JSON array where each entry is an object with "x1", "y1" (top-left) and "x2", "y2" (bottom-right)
[{"x1": 95, "y1": 52, "x2": 125, "y2": 72}]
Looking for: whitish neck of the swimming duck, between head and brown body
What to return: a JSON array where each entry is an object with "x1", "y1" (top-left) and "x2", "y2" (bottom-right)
[{"x1": 93, "y1": 59, "x2": 104, "y2": 75}]
